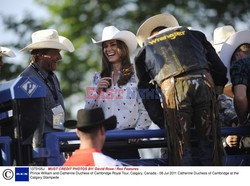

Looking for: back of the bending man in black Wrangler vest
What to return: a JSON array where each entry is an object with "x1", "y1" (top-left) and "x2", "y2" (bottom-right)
[{"x1": 144, "y1": 26, "x2": 227, "y2": 86}]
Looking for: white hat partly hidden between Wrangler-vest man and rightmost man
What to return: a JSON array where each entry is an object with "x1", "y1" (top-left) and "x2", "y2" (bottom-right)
[{"x1": 212, "y1": 25, "x2": 235, "y2": 53}]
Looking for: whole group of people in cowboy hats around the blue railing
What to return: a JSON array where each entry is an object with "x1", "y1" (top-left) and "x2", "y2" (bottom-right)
[{"x1": 0, "y1": 13, "x2": 250, "y2": 166}]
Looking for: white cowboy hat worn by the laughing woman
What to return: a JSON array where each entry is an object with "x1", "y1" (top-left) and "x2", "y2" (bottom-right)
[{"x1": 92, "y1": 26, "x2": 137, "y2": 54}]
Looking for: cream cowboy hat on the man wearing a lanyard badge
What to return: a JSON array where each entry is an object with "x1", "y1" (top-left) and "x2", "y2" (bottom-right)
[{"x1": 20, "y1": 29, "x2": 75, "y2": 52}]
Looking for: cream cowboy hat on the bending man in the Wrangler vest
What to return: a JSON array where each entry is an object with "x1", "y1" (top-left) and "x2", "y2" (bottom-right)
[{"x1": 136, "y1": 13, "x2": 179, "y2": 47}]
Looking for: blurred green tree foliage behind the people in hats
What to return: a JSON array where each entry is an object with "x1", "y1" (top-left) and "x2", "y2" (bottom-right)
[{"x1": 0, "y1": 0, "x2": 250, "y2": 115}]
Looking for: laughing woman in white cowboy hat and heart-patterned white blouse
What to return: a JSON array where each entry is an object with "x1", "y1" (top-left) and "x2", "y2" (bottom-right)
[{"x1": 85, "y1": 26, "x2": 151, "y2": 159}]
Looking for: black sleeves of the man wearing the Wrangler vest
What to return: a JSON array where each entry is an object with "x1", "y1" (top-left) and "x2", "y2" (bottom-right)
[{"x1": 135, "y1": 30, "x2": 227, "y2": 128}]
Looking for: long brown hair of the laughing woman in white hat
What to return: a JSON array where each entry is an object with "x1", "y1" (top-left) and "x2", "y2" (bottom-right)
[{"x1": 101, "y1": 40, "x2": 134, "y2": 86}]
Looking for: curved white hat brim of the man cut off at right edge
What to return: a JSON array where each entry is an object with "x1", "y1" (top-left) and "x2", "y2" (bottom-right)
[{"x1": 220, "y1": 30, "x2": 250, "y2": 82}]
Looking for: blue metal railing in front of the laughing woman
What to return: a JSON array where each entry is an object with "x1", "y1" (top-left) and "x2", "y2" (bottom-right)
[{"x1": 0, "y1": 127, "x2": 250, "y2": 166}]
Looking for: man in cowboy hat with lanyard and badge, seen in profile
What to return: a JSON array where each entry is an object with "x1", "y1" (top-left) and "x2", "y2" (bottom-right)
[{"x1": 20, "y1": 29, "x2": 74, "y2": 146}]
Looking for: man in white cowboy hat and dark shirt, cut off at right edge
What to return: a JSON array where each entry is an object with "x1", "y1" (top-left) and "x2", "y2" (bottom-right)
[{"x1": 220, "y1": 30, "x2": 250, "y2": 149}]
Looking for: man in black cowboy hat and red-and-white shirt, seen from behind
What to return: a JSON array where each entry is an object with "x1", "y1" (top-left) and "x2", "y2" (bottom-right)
[{"x1": 64, "y1": 107, "x2": 122, "y2": 166}]
